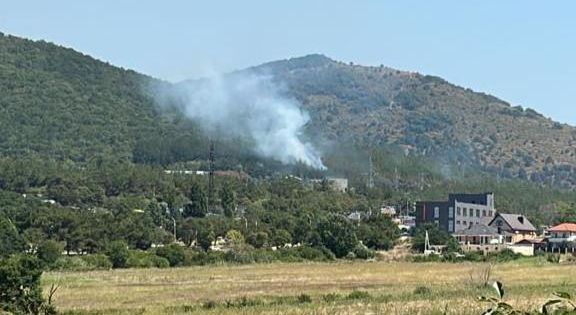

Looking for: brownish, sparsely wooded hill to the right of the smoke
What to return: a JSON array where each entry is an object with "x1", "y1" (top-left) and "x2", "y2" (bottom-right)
[{"x1": 248, "y1": 55, "x2": 576, "y2": 187}]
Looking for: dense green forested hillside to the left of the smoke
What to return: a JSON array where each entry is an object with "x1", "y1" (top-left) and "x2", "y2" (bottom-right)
[{"x1": 0, "y1": 35, "x2": 296, "y2": 174}]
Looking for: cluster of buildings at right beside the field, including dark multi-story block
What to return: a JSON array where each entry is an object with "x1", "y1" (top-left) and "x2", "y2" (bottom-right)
[{"x1": 415, "y1": 193, "x2": 576, "y2": 256}]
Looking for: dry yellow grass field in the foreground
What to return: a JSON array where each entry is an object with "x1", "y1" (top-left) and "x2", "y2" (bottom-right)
[{"x1": 44, "y1": 260, "x2": 576, "y2": 314}]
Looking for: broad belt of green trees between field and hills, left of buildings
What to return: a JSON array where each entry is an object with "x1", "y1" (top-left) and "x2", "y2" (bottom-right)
[{"x1": 0, "y1": 152, "x2": 397, "y2": 257}]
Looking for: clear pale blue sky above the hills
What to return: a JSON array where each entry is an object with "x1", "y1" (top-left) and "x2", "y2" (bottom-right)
[{"x1": 0, "y1": 0, "x2": 576, "y2": 125}]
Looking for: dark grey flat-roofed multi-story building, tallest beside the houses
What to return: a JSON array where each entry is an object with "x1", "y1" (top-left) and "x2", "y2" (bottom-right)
[{"x1": 416, "y1": 193, "x2": 496, "y2": 234}]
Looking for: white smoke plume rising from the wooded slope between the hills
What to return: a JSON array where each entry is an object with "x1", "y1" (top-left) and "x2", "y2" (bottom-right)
[{"x1": 155, "y1": 73, "x2": 325, "y2": 169}]
